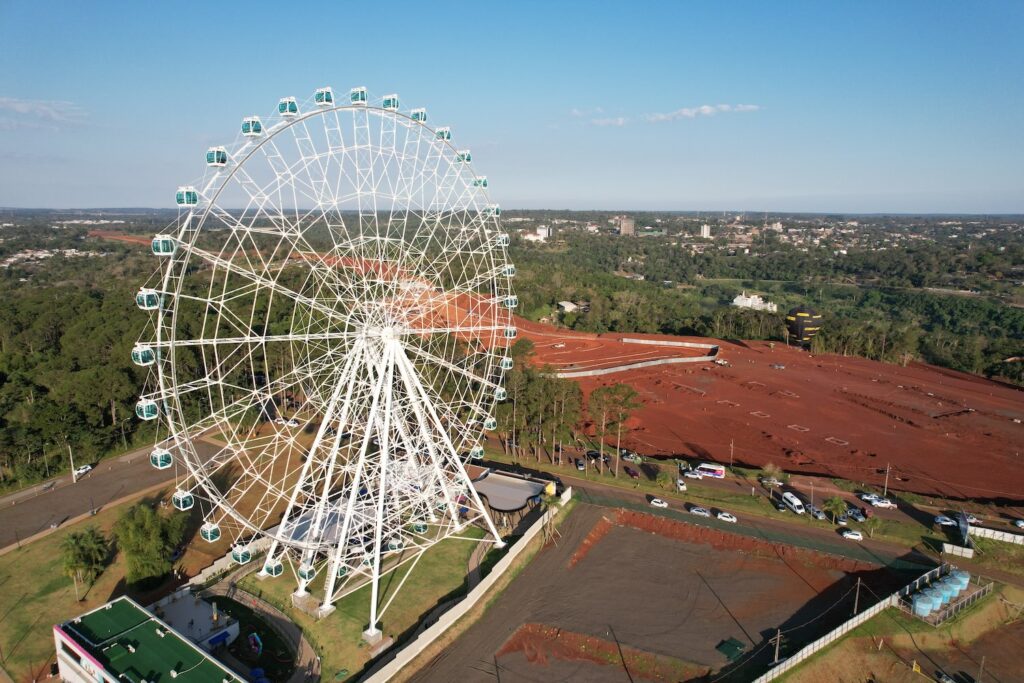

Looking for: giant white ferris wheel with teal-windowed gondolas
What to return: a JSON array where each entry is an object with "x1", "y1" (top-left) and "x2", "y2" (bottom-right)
[{"x1": 132, "y1": 87, "x2": 517, "y2": 636}]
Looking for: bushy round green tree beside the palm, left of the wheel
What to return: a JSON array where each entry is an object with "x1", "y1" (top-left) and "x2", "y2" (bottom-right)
[{"x1": 114, "y1": 504, "x2": 188, "y2": 584}]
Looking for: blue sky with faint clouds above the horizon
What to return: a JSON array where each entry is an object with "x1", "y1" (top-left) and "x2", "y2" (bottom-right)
[{"x1": 0, "y1": 0, "x2": 1024, "y2": 213}]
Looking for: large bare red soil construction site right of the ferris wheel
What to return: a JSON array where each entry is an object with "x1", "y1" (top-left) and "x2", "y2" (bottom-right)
[{"x1": 517, "y1": 321, "x2": 1024, "y2": 502}]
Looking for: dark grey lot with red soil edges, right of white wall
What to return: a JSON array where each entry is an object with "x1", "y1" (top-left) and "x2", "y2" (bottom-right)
[{"x1": 407, "y1": 505, "x2": 898, "y2": 682}]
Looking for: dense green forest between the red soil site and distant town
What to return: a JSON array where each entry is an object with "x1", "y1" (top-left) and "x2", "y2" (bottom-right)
[{"x1": 513, "y1": 233, "x2": 1024, "y2": 383}]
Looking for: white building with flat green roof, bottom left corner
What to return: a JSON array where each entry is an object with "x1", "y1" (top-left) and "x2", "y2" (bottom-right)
[{"x1": 53, "y1": 597, "x2": 245, "y2": 683}]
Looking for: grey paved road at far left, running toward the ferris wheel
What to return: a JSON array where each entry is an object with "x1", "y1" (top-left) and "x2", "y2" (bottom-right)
[{"x1": 0, "y1": 441, "x2": 216, "y2": 548}]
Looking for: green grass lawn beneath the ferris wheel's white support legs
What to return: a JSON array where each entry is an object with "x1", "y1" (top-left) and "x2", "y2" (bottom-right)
[{"x1": 240, "y1": 526, "x2": 485, "y2": 680}]
